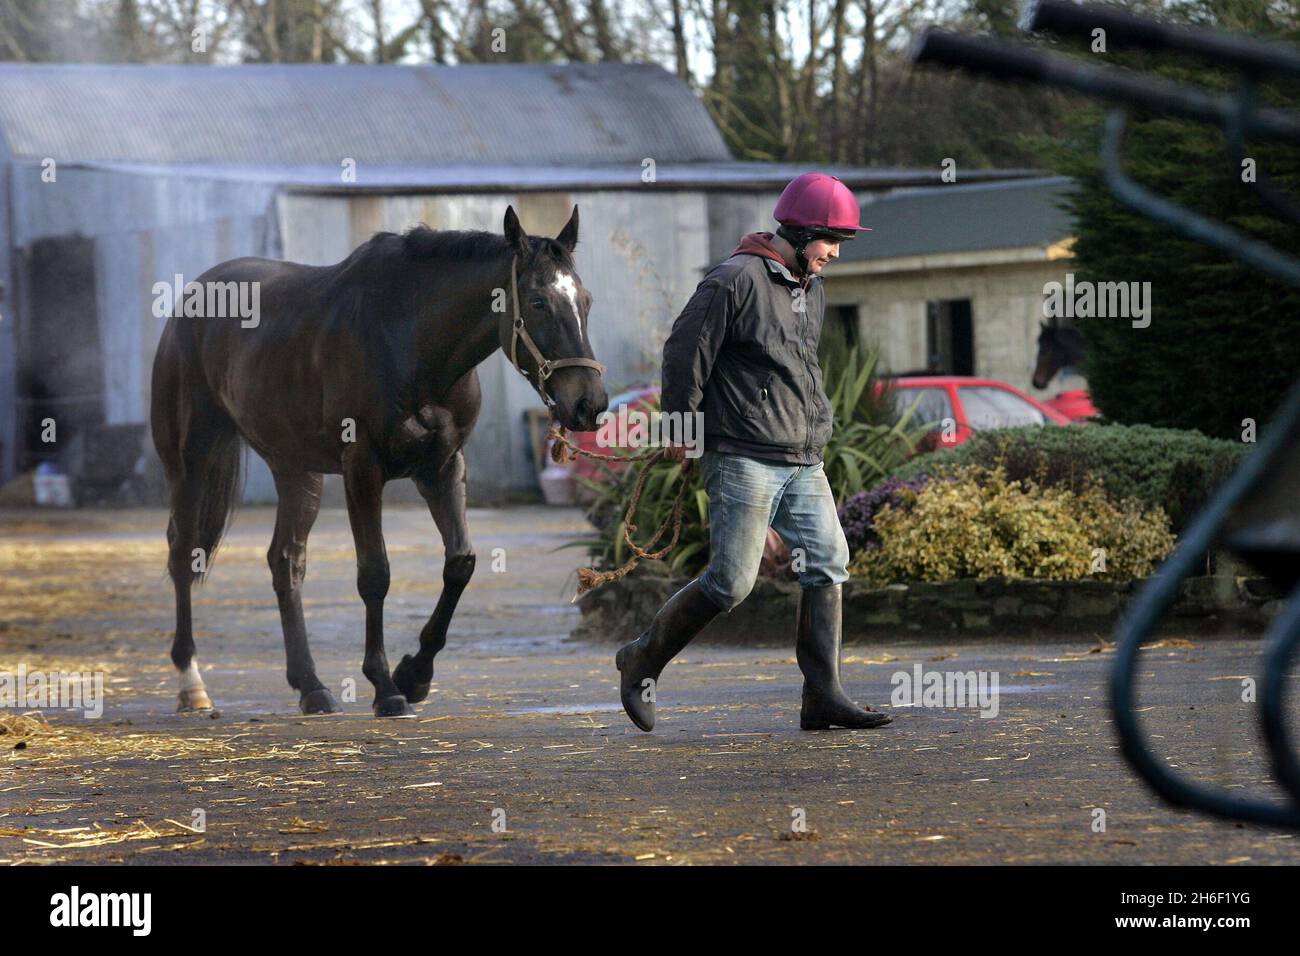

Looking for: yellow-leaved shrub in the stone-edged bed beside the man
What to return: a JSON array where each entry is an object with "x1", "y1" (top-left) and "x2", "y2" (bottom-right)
[{"x1": 849, "y1": 466, "x2": 1174, "y2": 584}]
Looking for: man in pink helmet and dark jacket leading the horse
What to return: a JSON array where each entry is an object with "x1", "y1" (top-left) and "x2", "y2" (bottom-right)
[{"x1": 615, "y1": 173, "x2": 891, "y2": 731}]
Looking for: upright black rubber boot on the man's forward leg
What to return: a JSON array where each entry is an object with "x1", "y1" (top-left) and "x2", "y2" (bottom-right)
[{"x1": 794, "y1": 584, "x2": 893, "y2": 730}]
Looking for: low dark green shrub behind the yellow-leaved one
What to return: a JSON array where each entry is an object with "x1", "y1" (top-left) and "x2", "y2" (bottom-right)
[{"x1": 892, "y1": 425, "x2": 1248, "y2": 532}]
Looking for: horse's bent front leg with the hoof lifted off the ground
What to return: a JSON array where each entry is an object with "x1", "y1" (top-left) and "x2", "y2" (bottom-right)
[{"x1": 393, "y1": 451, "x2": 475, "y2": 704}]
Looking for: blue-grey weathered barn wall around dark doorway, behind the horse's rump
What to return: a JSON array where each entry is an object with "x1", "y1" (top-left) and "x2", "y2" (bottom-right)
[{"x1": 12, "y1": 164, "x2": 277, "y2": 499}]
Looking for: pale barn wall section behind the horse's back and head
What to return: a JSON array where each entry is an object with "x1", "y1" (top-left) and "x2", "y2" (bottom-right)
[{"x1": 280, "y1": 190, "x2": 710, "y2": 501}]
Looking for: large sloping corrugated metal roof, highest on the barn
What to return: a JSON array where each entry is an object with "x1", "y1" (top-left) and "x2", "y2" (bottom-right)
[{"x1": 0, "y1": 64, "x2": 731, "y2": 170}]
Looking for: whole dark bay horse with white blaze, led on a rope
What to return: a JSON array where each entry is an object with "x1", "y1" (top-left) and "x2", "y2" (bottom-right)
[{"x1": 152, "y1": 207, "x2": 608, "y2": 717}]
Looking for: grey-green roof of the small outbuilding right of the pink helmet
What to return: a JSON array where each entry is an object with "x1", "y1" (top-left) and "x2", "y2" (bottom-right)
[{"x1": 840, "y1": 176, "x2": 1074, "y2": 263}]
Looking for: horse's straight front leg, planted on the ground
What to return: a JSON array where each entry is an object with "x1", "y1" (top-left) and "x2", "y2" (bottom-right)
[{"x1": 343, "y1": 442, "x2": 415, "y2": 717}]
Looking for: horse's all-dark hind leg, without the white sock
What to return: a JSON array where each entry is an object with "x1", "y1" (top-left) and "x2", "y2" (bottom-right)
[{"x1": 267, "y1": 472, "x2": 341, "y2": 714}]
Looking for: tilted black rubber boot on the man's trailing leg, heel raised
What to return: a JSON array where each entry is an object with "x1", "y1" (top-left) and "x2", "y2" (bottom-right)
[{"x1": 614, "y1": 578, "x2": 722, "y2": 731}]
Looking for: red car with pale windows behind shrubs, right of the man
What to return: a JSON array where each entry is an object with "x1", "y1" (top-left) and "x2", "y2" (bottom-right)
[{"x1": 889, "y1": 375, "x2": 1070, "y2": 447}]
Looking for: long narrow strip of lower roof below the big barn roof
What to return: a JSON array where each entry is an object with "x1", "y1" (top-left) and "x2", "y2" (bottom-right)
[{"x1": 35, "y1": 160, "x2": 1041, "y2": 193}]
